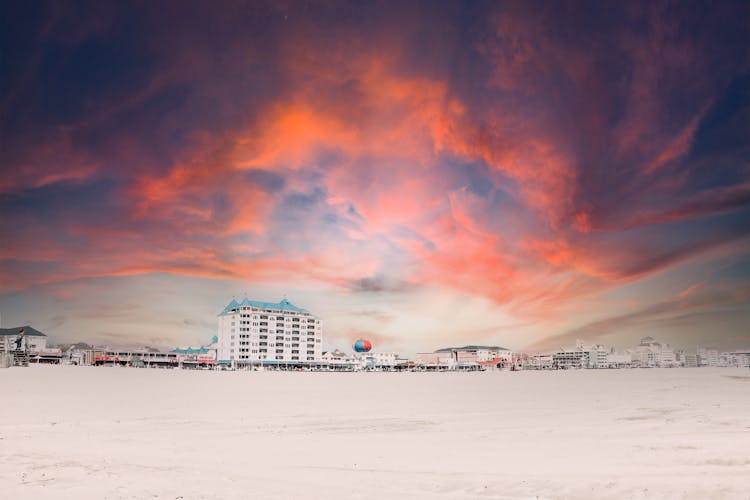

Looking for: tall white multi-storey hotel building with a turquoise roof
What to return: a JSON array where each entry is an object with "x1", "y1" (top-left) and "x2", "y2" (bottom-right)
[{"x1": 217, "y1": 298, "x2": 323, "y2": 365}]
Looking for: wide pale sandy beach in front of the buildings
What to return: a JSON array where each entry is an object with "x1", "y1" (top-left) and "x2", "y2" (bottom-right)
[{"x1": 0, "y1": 366, "x2": 750, "y2": 499}]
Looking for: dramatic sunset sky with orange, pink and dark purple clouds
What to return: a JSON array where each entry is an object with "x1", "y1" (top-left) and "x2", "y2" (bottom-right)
[{"x1": 0, "y1": 1, "x2": 750, "y2": 354}]
